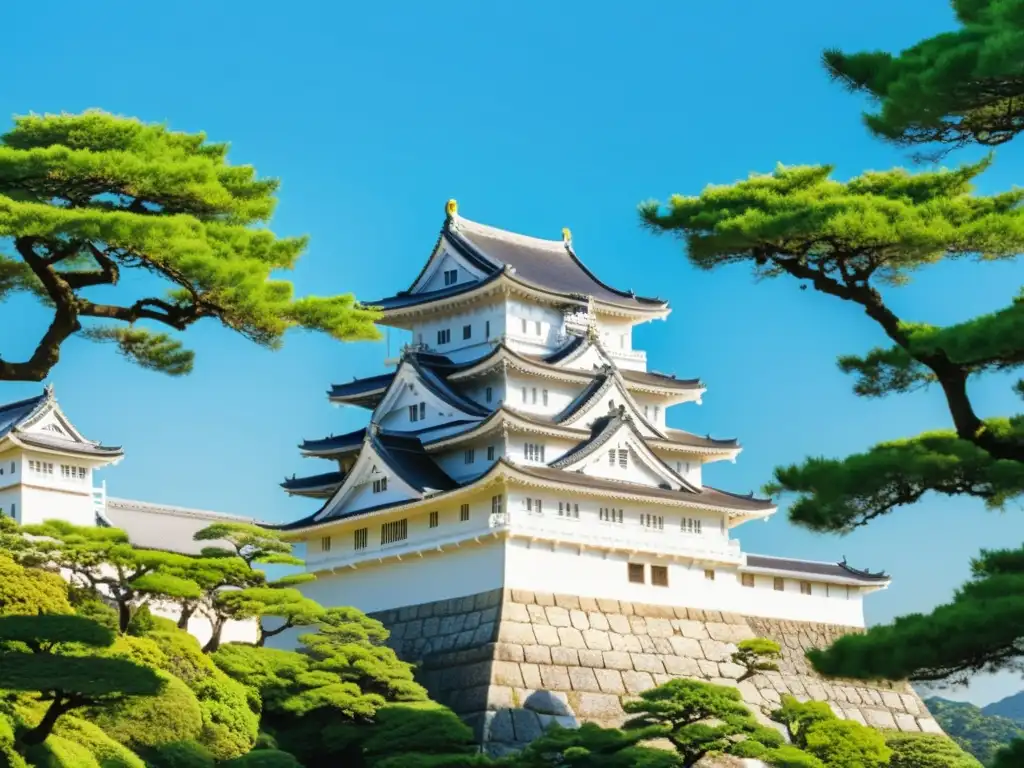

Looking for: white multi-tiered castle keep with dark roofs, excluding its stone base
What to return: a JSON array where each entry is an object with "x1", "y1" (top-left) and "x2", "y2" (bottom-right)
[{"x1": 284, "y1": 206, "x2": 888, "y2": 627}]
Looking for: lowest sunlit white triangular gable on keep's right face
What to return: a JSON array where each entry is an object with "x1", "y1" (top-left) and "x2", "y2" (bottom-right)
[{"x1": 551, "y1": 415, "x2": 698, "y2": 493}]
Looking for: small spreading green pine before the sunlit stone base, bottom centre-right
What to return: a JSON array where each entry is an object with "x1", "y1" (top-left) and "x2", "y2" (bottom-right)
[{"x1": 623, "y1": 679, "x2": 762, "y2": 766}]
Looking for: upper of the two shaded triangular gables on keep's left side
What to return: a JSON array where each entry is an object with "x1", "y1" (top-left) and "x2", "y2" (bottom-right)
[{"x1": 371, "y1": 357, "x2": 488, "y2": 431}]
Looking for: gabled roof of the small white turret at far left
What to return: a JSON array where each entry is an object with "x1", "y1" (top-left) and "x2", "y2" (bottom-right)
[{"x1": 0, "y1": 385, "x2": 124, "y2": 459}]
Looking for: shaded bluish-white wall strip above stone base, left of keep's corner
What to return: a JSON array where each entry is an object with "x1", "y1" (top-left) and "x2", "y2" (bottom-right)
[{"x1": 300, "y1": 531, "x2": 505, "y2": 612}]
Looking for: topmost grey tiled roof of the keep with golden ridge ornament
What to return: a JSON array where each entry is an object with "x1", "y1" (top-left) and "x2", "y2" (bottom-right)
[{"x1": 366, "y1": 207, "x2": 668, "y2": 313}]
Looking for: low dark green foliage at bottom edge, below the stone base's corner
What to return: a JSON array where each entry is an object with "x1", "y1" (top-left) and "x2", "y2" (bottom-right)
[{"x1": 509, "y1": 723, "x2": 684, "y2": 768}]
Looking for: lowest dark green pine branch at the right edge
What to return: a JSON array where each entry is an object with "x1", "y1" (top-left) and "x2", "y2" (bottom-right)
[{"x1": 808, "y1": 548, "x2": 1024, "y2": 681}]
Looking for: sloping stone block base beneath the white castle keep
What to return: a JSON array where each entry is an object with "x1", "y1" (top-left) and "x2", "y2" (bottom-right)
[{"x1": 374, "y1": 590, "x2": 941, "y2": 753}]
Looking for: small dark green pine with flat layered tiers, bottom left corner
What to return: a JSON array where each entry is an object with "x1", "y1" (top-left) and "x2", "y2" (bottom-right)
[{"x1": 0, "y1": 614, "x2": 162, "y2": 746}]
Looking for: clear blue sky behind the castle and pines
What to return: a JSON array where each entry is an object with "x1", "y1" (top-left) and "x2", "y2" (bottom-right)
[{"x1": 0, "y1": 0, "x2": 1024, "y2": 703}]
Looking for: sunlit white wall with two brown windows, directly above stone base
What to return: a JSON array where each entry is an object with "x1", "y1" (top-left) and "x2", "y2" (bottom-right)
[{"x1": 505, "y1": 540, "x2": 864, "y2": 627}]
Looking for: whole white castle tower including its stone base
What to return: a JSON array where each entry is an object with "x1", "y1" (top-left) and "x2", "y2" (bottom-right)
[{"x1": 270, "y1": 201, "x2": 934, "y2": 743}]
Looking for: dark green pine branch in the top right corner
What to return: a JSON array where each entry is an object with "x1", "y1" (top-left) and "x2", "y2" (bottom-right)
[{"x1": 823, "y1": 0, "x2": 1024, "y2": 154}]
